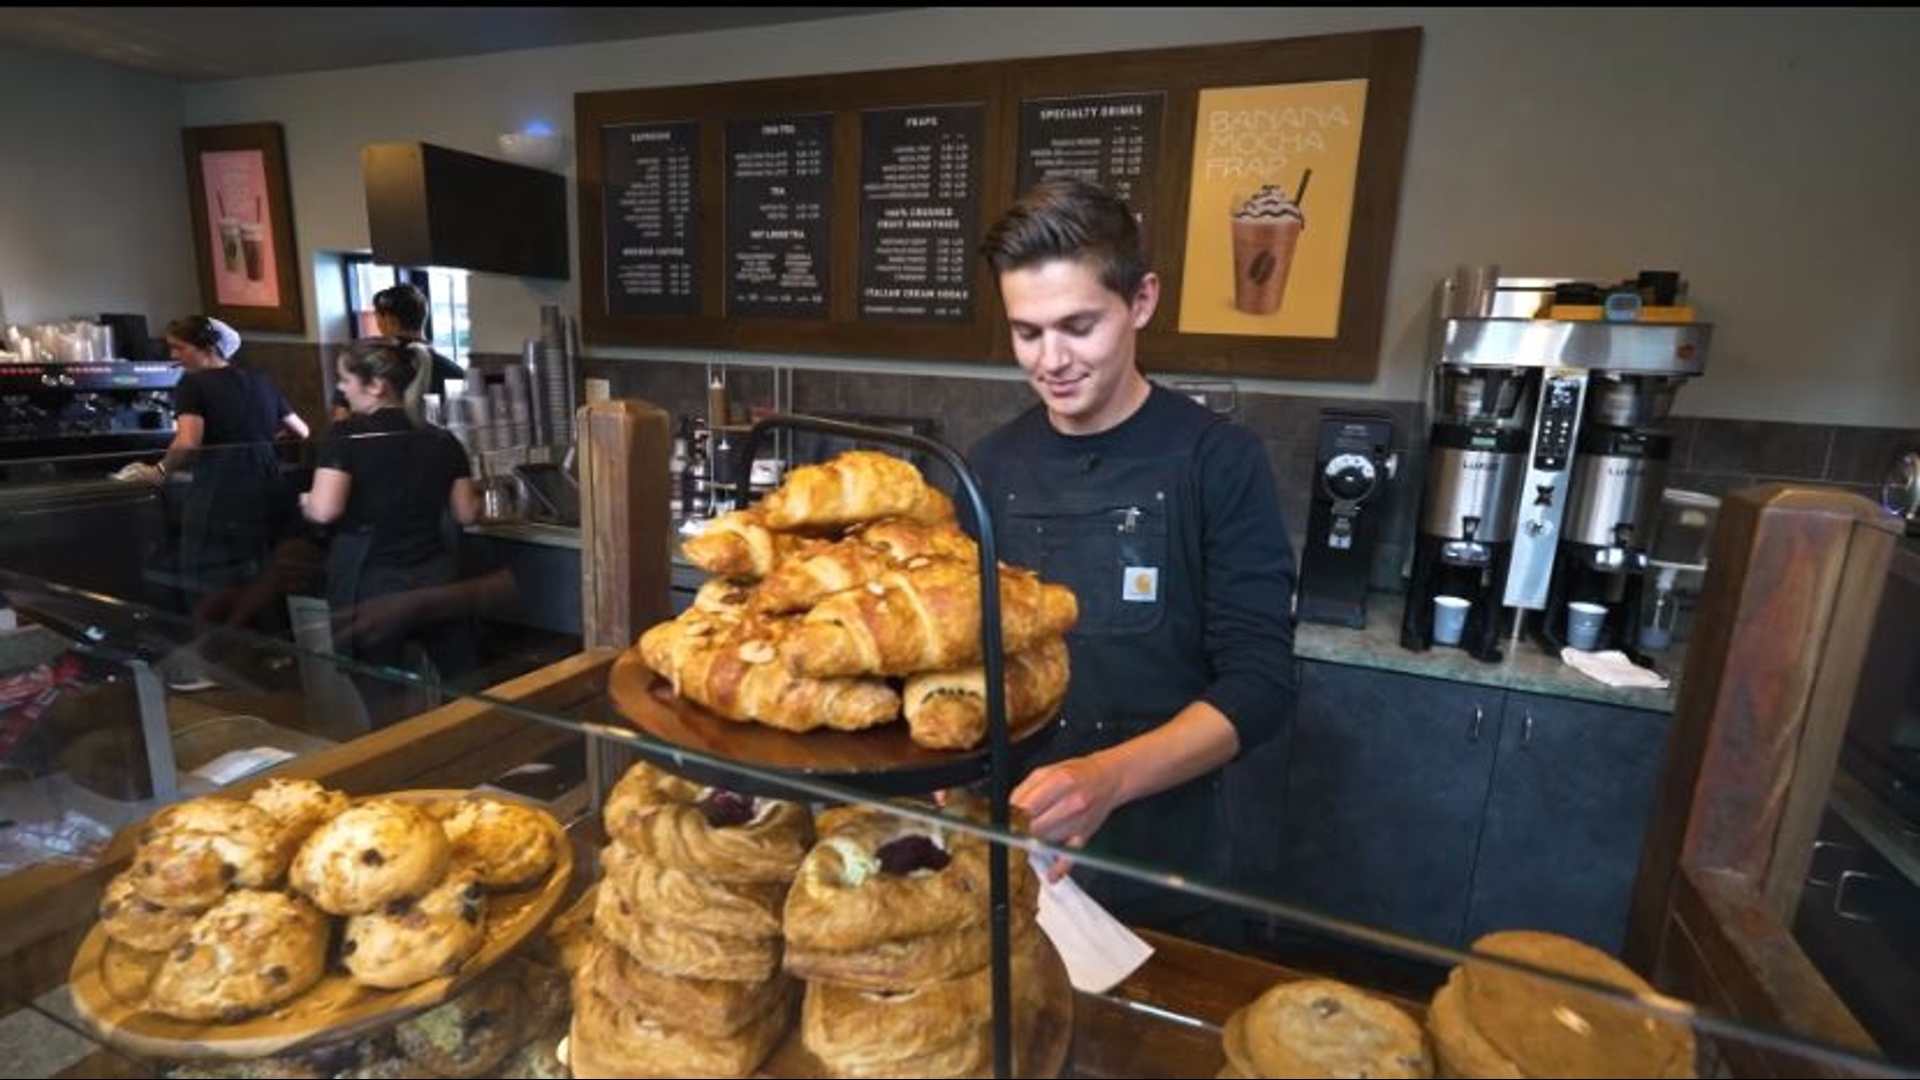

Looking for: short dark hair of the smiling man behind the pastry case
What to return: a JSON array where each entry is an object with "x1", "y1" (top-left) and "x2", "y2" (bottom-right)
[{"x1": 979, "y1": 179, "x2": 1148, "y2": 300}]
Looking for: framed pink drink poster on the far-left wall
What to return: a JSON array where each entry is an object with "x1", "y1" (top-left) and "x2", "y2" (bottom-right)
[{"x1": 182, "y1": 123, "x2": 305, "y2": 334}]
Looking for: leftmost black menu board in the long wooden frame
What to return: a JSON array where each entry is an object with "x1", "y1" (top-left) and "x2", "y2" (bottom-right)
[{"x1": 601, "y1": 121, "x2": 701, "y2": 315}]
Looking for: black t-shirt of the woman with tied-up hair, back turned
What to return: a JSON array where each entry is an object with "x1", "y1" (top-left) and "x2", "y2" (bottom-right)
[{"x1": 315, "y1": 407, "x2": 472, "y2": 567}]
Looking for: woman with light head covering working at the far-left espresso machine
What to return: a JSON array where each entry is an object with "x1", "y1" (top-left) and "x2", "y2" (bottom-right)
[{"x1": 138, "y1": 315, "x2": 307, "y2": 592}]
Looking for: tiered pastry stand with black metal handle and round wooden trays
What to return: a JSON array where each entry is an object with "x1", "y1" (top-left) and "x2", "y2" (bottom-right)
[{"x1": 609, "y1": 415, "x2": 1073, "y2": 1078}]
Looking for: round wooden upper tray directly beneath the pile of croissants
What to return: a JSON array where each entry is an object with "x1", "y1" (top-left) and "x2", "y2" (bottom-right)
[{"x1": 607, "y1": 650, "x2": 1060, "y2": 798}]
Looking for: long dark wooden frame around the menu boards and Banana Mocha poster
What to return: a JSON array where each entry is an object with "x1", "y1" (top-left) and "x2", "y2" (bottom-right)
[{"x1": 574, "y1": 27, "x2": 1421, "y2": 382}]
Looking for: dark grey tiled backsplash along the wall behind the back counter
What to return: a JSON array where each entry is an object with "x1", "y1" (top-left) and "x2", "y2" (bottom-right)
[{"x1": 518, "y1": 357, "x2": 1920, "y2": 588}]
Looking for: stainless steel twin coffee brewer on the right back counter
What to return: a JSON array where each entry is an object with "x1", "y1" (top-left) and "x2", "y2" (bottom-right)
[{"x1": 1402, "y1": 279, "x2": 1713, "y2": 661}]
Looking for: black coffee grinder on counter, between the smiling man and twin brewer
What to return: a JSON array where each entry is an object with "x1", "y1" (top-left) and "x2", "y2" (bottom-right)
[{"x1": 1300, "y1": 409, "x2": 1400, "y2": 630}]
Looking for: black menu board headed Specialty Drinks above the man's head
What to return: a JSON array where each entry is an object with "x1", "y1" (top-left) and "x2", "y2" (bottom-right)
[{"x1": 1020, "y1": 92, "x2": 1167, "y2": 234}]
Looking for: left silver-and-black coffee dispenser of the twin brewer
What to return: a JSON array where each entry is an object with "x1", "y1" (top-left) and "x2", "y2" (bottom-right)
[{"x1": 1400, "y1": 357, "x2": 1540, "y2": 663}]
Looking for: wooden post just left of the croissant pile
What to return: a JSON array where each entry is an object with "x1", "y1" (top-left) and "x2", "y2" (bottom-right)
[{"x1": 576, "y1": 398, "x2": 674, "y2": 650}]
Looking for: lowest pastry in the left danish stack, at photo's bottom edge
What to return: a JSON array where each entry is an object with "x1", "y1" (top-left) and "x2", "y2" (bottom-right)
[{"x1": 568, "y1": 978, "x2": 793, "y2": 1076}]
